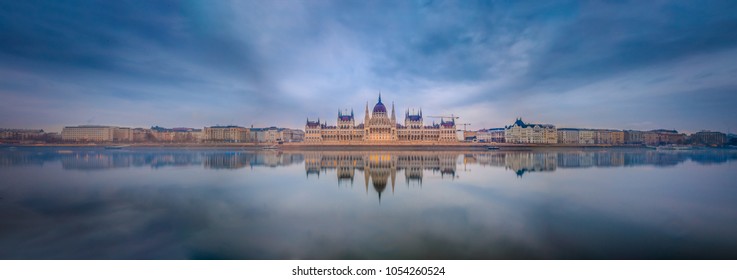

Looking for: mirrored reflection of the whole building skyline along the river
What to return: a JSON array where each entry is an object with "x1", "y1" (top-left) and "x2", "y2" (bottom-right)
[{"x1": 0, "y1": 148, "x2": 737, "y2": 174}]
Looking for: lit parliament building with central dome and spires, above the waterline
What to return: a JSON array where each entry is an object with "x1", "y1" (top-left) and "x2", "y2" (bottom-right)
[{"x1": 304, "y1": 94, "x2": 458, "y2": 143}]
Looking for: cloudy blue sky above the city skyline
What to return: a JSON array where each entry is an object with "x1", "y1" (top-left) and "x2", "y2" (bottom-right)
[{"x1": 0, "y1": 0, "x2": 737, "y2": 132}]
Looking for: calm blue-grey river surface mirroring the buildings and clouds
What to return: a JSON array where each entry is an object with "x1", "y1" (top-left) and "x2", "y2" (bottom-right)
[{"x1": 0, "y1": 147, "x2": 737, "y2": 259}]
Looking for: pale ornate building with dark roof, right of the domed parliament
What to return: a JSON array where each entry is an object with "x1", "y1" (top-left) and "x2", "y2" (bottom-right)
[{"x1": 504, "y1": 119, "x2": 558, "y2": 144}]
